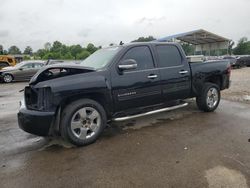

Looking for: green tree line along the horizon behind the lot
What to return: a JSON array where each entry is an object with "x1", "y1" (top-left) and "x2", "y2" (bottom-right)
[{"x1": 0, "y1": 36, "x2": 250, "y2": 60}]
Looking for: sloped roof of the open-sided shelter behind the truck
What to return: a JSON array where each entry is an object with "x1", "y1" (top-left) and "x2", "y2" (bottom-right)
[{"x1": 157, "y1": 29, "x2": 230, "y2": 45}]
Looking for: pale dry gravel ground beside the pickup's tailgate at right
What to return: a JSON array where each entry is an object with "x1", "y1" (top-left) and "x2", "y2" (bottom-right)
[{"x1": 222, "y1": 67, "x2": 250, "y2": 104}]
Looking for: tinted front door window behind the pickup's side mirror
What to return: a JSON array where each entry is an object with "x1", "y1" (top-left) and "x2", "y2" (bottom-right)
[{"x1": 122, "y1": 46, "x2": 154, "y2": 70}]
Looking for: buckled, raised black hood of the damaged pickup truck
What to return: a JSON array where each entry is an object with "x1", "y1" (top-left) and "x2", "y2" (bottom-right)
[{"x1": 29, "y1": 63, "x2": 95, "y2": 85}]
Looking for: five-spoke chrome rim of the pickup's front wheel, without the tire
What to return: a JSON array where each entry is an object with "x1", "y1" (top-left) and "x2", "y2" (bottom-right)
[{"x1": 70, "y1": 107, "x2": 101, "y2": 140}]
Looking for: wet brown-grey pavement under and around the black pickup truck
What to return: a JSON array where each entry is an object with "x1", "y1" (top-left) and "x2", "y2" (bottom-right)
[{"x1": 0, "y1": 83, "x2": 250, "y2": 188}]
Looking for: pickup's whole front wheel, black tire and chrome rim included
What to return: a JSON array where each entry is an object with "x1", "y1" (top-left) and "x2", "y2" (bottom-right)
[{"x1": 60, "y1": 99, "x2": 107, "y2": 146}]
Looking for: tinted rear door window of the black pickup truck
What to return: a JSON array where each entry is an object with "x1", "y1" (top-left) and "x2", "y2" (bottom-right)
[{"x1": 156, "y1": 45, "x2": 181, "y2": 67}]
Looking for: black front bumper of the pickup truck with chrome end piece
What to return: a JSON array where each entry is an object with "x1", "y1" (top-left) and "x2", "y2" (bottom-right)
[{"x1": 17, "y1": 100, "x2": 55, "y2": 136}]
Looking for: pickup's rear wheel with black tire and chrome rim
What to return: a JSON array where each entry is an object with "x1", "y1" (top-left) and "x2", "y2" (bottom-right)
[{"x1": 196, "y1": 83, "x2": 220, "y2": 112}]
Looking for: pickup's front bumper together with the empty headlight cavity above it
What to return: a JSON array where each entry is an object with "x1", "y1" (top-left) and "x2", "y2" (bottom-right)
[{"x1": 18, "y1": 86, "x2": 56, "y2": 136}]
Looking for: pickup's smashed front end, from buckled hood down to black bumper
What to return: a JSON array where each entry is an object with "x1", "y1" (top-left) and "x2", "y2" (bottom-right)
[{"x1": 18, "y1": 65, "x2": 94, "y2": 136}]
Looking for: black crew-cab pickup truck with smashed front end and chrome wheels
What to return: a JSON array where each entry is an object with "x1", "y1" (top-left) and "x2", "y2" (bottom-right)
[{"x1": 18, "y1": 42, "x2": 231, "y2": 146}]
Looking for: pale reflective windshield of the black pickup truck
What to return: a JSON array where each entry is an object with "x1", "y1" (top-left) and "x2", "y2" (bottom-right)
[{"x1": 81, "y1": 47, "x2": 121, "y2": 69}]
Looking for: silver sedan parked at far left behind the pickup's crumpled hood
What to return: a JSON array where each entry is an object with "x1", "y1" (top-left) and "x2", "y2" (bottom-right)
[{"x1": 0, "y1": 61, "x2": 45, "y2": 83}]
